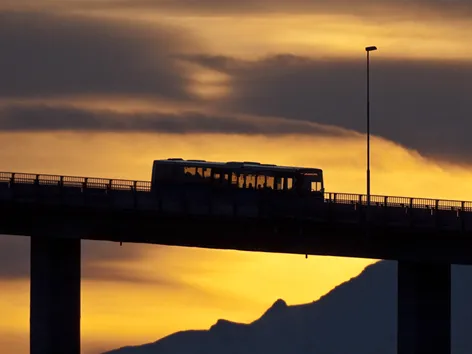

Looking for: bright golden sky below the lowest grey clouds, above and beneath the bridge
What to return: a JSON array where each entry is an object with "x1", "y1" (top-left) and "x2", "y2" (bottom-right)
[{"x1": 4, "y1": 134, "x2": 472, "y2": 353}]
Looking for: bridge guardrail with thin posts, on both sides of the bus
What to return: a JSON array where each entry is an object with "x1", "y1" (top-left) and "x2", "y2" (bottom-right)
[{"x1": 0, "y1": 172, "x2": 472, "y2": 212}]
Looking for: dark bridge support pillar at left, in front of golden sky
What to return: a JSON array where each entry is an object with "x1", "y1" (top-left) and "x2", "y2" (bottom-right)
[{"x1": 30, "y1": 236, "x2": 81, "y2": 354}]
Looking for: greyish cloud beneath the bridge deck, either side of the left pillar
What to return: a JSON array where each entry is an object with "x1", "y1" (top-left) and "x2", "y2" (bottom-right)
[{"x1": 0, "y1": 235, "x2": 184, "y2": 287}]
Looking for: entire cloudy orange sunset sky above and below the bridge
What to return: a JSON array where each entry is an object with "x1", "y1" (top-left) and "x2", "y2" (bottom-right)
[{"x1": 0, "y1": 0, "x2": 472, "y2": 354}]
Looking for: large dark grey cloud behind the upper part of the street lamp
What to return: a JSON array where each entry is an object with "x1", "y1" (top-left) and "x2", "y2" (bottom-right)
[{"x1": 180, "y1": 55, "x2": 472, "y2": 162}]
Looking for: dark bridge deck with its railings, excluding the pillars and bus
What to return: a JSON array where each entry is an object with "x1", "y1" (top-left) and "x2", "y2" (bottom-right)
[{"x1": 0, "y1": 173, "x2": 472, "y2": 264}]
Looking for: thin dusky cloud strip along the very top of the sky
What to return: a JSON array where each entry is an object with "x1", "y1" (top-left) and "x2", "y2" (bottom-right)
[{"x1": 74, "y1": 0, "x2": 472, "y2": 21}]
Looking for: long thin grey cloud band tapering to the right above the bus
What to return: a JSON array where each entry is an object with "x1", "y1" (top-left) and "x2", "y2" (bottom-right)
[{"x1": 0, "y1": 105, "x2": 352, "y2": 136}]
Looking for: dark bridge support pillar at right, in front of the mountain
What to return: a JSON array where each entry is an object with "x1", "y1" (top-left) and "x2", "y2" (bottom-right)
[{"x1": 397, "y1": 261, "x2": 451, "y2": 354}]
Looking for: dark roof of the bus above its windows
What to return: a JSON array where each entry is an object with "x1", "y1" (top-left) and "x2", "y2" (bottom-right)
[{"x1": 154, "y1": 158, "x2": 322, "y2": 173}]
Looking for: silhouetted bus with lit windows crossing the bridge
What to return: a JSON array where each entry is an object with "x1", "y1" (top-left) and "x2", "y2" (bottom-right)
[{"x1": 151, "y1": 158, "x2": 324, "y2": 197}]
